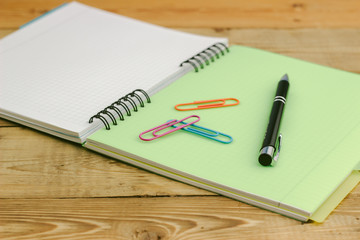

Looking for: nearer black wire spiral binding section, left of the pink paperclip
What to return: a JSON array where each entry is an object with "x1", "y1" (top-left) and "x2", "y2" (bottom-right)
[{"x1": 89, "y1": 89, "x2": 151, "y2": 130}]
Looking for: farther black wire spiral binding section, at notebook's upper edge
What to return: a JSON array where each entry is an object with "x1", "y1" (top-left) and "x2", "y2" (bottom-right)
[{"x1": 180, "y1": 42, "x2": 230, "y2": 72}]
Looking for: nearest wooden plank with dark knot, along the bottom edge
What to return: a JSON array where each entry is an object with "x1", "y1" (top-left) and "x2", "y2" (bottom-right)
[{"x1": 0, "y1": 194, "x2": 360, "y2": 240}]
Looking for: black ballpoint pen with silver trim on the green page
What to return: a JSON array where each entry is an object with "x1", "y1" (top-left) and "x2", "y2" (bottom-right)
[{"x1": 259, "y1": 74, "x2": 289, "y2": 166}]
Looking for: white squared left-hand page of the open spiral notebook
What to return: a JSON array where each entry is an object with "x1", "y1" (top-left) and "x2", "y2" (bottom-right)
[{"x1": 0, "y1": 2, "x2": 226, "y2": 142}]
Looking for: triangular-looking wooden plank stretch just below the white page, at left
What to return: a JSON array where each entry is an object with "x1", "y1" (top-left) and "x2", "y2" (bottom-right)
[{"x1": 0, "y1": 127, "x2": 211, "y2": 198}]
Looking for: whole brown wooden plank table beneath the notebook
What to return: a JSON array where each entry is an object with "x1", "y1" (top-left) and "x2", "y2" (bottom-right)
[{"x1": 0, "y1": 0, "x2": 360, "y2": 240}]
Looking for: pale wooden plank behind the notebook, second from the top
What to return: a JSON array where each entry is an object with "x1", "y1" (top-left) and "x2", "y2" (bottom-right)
[{"x1": 0, "y1": 28, "x2": 360, "y2": 72}]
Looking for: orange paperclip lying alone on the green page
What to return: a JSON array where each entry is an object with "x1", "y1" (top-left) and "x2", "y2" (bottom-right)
[{"x1": 175, "y1": 98, "x2": 240, "y2": 111}]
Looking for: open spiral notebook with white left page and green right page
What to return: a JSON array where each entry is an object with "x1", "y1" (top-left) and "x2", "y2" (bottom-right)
[{"x1": 0, "y1": 3, "x2": 360, "y2": 221}]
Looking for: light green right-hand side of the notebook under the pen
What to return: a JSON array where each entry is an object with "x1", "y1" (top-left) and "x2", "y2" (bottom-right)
[{"x1": 86, "y1": 46, "x2": 360, "y2": 220}]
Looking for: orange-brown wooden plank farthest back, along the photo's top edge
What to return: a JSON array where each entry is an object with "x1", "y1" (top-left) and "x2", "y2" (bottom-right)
[{"x1": 0, "y1": 0, "x2": 360, "y2": 29}]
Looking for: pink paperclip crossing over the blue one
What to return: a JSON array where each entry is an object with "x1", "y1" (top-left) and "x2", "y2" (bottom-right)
[{"x1": 139, "y1": 115, "x2": 200, "y2": 141}]
